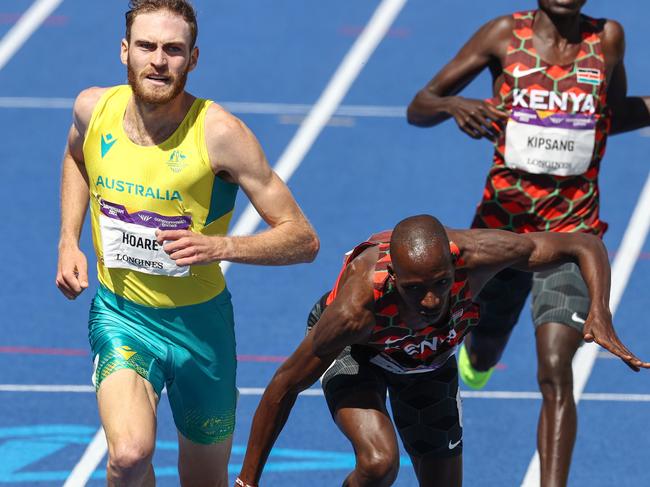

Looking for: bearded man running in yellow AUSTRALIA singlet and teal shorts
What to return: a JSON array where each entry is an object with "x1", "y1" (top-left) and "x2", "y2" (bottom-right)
[{"x1": 56, "y1": 0, "x2": 318, "y2": 486}]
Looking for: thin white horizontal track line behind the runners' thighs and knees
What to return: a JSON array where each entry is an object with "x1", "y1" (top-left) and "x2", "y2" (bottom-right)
[{"x1": 0, "y1": 384, "x2": 650, "y2": 404}]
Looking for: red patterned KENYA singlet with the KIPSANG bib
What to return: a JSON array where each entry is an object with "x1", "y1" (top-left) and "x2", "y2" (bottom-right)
[{"x1": 472, "y1": 11, "x2": 610, "y2": 236}]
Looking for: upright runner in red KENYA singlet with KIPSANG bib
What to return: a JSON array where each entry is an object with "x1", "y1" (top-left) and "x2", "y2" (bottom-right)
[{"x1": 408, "y1": 0, "x2": 650, "y2": 486}]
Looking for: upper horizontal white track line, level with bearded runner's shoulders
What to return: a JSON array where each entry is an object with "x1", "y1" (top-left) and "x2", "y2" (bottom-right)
[{"x1": 0, "y1": 96, "x2": 406, "y2": 118}]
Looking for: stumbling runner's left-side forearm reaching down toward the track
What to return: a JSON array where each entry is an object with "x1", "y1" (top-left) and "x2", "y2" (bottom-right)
[{"x1": 239, "y1": 325, "x2": 341, "y2": 486}]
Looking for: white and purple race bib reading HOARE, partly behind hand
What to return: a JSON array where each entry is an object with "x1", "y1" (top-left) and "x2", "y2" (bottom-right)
[{"x1": 99, "y1": 199, "x2": 192, "y2": 277}]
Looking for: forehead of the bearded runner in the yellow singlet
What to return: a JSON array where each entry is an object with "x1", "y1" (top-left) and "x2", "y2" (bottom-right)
[{"x1": 131, "y1": 10, "x2": 192, "y2": 44}]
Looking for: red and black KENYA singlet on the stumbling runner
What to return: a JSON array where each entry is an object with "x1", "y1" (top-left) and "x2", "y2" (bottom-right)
[{"x1": 327, "y1": 231, "x2": 479, "y2": 374}]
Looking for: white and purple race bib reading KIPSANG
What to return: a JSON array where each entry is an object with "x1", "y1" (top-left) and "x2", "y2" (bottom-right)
[{"x1": 505, "y1": 108, "x2": 596, "y2": 176}]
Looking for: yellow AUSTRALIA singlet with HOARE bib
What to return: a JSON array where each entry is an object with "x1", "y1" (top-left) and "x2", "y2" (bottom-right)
[{"x1": 83, "y1": 86, "x2": 238, "y2": 307}]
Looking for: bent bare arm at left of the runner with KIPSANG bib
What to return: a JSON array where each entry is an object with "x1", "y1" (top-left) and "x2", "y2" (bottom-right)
[{"x1": 407, "y1": 16, "x2": 513, "y2": 139}]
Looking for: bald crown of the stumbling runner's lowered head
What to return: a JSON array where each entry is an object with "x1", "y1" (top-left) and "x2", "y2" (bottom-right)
[{"x1": 390, "y1": 215, "x2": 451, "y2": 271}]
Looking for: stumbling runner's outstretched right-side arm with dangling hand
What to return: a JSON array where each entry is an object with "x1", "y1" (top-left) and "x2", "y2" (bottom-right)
[{"x1": 450, "y1": 230, "x2": 650, "y2": 371}]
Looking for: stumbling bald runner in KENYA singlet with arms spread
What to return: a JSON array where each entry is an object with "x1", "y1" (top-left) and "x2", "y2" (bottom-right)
[{"x1": 236, "y1": 215, "x2": 650, "y2": 487}]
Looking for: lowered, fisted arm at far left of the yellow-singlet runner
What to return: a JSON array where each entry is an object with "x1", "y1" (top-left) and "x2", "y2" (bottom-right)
[{"x1": 56, "y1": 88, "x2": 104, "y2": 299}]
